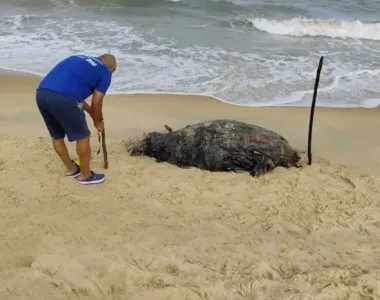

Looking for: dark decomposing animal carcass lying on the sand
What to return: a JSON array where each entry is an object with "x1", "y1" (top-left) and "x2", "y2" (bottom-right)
[{"x1": 131, "y1": 120, "x2": 300, "y2": 176}]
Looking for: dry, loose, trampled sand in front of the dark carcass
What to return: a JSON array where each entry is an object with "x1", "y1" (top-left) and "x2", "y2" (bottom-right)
[{"x1": 0, "y1": 137, "x2": 380, "y2": 300}]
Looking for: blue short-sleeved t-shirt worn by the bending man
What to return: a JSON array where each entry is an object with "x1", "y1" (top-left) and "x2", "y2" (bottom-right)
[{"x1": 37, "y1": 55, "x2": 112, "y2": 102}]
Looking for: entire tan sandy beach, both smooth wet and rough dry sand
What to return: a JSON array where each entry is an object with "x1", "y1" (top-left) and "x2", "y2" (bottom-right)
[{"x1": 0, "y1": 73, "x2": 380, "y2": 300}]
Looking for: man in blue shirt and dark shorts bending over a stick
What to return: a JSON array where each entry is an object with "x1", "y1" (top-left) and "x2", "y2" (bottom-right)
[{"x1": 36, "y1": 54, "x2": 116, "y2": 184}]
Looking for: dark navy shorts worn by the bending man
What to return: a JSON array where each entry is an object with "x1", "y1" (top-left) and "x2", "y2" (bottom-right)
[{"x1": 36, "y1": 89, "x2": 91, "y2": 142}]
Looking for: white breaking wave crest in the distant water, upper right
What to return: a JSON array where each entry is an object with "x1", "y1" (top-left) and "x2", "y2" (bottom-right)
[{"x1": 250, "y1": 18, "x2": 380, "y2": 40}]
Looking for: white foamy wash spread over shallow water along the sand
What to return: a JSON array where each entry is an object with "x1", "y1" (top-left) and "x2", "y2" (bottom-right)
[{"x1": 0, "y1": 15, "x2": 379, "y2": 107}]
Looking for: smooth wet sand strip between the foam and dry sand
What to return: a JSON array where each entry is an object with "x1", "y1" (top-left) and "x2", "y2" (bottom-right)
[{"x1": 0, "y1": 69, "x2": 380, "y2": 174}]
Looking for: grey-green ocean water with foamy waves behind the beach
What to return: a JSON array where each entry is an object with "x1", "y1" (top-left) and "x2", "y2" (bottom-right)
[{"x1": 0, "y1": 0, "x2": 380, "y2": 107}]
